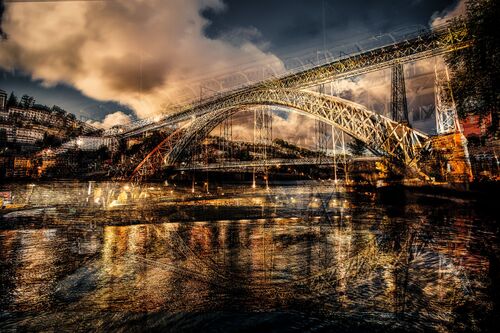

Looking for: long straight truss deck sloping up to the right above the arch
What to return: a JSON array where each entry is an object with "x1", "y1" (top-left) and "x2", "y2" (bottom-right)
[{"x1": 116, "y1": 20, "x2": 472, "y2": 137}]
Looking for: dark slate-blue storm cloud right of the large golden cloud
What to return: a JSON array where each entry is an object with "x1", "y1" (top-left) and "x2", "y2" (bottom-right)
[{"x1": 203, "y1": 0, "x2": 457, "y2": 56}]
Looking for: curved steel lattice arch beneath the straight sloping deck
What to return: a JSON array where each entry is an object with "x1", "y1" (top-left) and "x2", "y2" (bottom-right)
[{"x1": 132, "y1": 87, "x2": 428, "y2": 179}]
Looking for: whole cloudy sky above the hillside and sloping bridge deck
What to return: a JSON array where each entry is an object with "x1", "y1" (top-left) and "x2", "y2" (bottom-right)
[{"x1": 0, "y1": 0, "x2": 463, "y2": 126}]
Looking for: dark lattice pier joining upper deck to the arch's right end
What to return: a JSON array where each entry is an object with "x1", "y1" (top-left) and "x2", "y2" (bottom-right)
[{"x1": 391, "y1": 63, "x2": 409, "y2": 124}]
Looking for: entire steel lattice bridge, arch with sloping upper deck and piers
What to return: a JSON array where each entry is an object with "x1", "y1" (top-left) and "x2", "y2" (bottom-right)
[{"x1": 118, "y1": 20, "x2": 472, "y2": 179}]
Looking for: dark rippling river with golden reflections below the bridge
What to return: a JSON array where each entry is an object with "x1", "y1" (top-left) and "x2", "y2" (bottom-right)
[{"x1": 0, "y1": 182, "x2": 500, "y2": 332}]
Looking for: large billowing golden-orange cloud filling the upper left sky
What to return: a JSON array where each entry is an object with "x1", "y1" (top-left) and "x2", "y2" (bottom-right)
[{"x1": 0, "y1": 0, "x2": 282, "y2": 118}]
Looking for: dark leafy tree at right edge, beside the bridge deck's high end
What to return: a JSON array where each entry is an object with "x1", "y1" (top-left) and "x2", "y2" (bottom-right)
[{"x1": 445, "y1": 0, "x2": 500, "y2": 135}]
